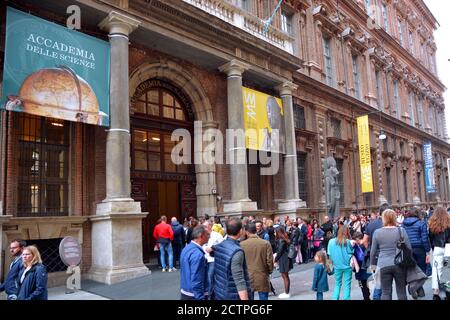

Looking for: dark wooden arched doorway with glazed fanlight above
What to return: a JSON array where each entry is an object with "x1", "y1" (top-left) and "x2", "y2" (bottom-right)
[{"x1": 130, "y1": 79, "x2": 196, "y2": 262}]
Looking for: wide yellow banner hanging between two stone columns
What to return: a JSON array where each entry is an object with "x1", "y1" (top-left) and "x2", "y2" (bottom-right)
[{"x1": 242, "y1": 87, "x2": 286, "y2": 153}]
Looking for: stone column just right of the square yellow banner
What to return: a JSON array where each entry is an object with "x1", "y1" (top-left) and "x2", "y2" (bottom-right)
[{"x1": 277, "y1": 82, "x2": 306, "y2": 213}]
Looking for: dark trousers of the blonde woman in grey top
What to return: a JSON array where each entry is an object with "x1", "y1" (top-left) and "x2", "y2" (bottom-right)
[{"x1": 380, "y1": 266, "x2": 407, "y2": 300}]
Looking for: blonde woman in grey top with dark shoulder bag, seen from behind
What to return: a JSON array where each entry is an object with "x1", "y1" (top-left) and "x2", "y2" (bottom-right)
[{"x1": 370, "y1": 209, "x2": 412, "y2": 300}]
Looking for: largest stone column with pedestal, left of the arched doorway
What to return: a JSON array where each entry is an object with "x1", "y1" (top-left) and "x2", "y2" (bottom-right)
[{"x1": 88, "y1": 11, "x2": 150, "y2": 284}]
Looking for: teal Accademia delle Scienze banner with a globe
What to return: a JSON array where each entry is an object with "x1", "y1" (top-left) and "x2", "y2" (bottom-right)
[{"x1": 0, "y1": 7, "x2": 110, "y2": 126}]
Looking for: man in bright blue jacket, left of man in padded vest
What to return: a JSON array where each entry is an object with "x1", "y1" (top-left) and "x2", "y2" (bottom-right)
[{"x1": 180, "y1": 225, "x2": 209, "y2": 300}]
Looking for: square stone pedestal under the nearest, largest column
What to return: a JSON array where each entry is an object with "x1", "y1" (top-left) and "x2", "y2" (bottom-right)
[{"x1": 86, "y1": 199, "x2": 151, "y2": 284}]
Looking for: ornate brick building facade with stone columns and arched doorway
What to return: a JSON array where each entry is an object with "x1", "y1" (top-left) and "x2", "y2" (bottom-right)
[{"x1": 0, "y1": 0, "x2": 450, "y2": 283}]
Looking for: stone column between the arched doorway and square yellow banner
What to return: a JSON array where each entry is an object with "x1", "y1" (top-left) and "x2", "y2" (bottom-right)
[{"x1": 219, "y1": 60, "x2": 258, "y2": 215}]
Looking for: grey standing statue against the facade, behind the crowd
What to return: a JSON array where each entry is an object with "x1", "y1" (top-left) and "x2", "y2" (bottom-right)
[{"x1": 325, "y1": 157, "x2": 341, "y2": 219}]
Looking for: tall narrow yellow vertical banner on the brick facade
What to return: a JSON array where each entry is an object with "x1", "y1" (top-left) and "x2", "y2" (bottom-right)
[{"x1": 356, "y1": 115, "x2": 373, "y2": 193}]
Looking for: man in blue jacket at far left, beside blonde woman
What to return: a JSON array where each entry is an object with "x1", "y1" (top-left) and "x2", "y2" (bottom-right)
[{"x1": 0, "y1": 240, "x2": 26, "y2": 300}]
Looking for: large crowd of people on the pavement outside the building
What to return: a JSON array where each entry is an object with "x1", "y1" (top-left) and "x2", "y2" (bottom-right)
[{"x1": 163, "y1": 204, "x2": 450, "y2": 300}]
